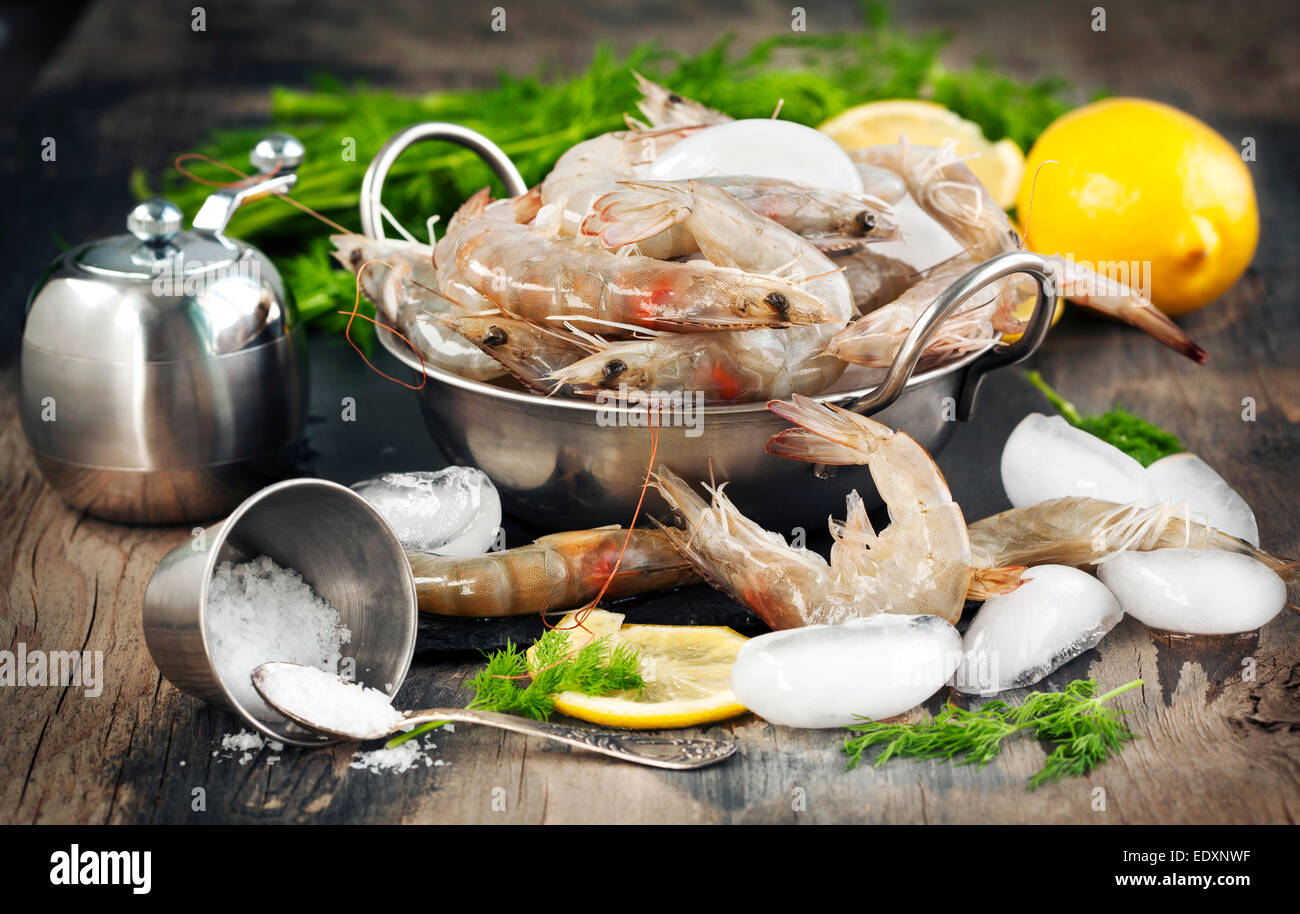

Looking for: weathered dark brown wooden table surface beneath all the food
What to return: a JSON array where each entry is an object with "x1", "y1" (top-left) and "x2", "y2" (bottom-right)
[{"x1": 0, "y1": 0, "x2": 1300, "y2": 823}]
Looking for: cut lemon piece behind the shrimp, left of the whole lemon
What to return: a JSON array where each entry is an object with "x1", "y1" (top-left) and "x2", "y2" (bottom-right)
[{"x1": 818, "y1": 99, "x2": 1024, "y2": 209}]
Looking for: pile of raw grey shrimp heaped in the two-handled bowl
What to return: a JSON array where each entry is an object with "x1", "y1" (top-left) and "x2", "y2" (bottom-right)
[{"x1": 333, "y1": 75, "x2": 1205, "y2": 403}]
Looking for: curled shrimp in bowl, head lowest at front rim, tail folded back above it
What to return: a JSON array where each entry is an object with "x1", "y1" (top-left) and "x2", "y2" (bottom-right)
[{"x1": 555, "y1": 181, "x2": 853, "y2": 402}]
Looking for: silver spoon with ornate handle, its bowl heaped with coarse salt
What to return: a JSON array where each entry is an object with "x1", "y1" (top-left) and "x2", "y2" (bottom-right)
[{"x1": 252, "y1": 660, "x2": 736, "y2": 770}]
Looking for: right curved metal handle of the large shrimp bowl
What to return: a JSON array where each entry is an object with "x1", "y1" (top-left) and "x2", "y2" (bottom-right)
[{"x1": 849, "y1": 251, "x2": 1056, "y2": 421}]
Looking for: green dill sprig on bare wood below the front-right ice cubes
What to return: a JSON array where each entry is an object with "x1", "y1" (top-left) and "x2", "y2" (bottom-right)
[{"x1": 844, "y1": 679, "x2": 1143, "y2": 789}]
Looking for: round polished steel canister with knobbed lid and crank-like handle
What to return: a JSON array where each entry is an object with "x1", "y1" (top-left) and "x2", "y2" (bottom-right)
[{"x1": 20, "y1": 134, "x2": 307, "y2": 524}]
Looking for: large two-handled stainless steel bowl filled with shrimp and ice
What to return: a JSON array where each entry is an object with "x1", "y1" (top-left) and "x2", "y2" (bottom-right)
[{"x1": 361, "y1": 124, "x2": 1054, "y2": 532}]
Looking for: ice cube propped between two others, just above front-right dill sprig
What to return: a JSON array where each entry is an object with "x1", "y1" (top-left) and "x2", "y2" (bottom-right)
[{"x1": 954, "y1": 564, "x2": 1123, "y2": 696}]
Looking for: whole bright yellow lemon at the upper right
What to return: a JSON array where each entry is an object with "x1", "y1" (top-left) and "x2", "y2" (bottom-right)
[{"x1": 1017, "y1": 99, "x2": 1260, "y2": 315}]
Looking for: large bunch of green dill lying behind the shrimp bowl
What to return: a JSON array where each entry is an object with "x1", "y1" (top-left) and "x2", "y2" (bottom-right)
[{"x1": 139, "y1": 1, "x2": 1071, "y2": 341}]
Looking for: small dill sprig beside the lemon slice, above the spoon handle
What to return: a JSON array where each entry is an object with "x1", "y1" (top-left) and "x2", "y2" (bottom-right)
[{"x1": 386, "y1": 628, "x2": 645, "y2": 748}]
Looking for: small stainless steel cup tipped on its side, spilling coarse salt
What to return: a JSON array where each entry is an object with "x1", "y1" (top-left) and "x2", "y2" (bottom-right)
[{"x1": 144, "y1": 478, "x2": 416, "y2": 746}]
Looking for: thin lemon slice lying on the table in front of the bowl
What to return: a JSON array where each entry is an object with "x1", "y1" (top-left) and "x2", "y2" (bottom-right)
[{"x1": 535, "y1": 610, "x2": 749, "y2": 729}]
